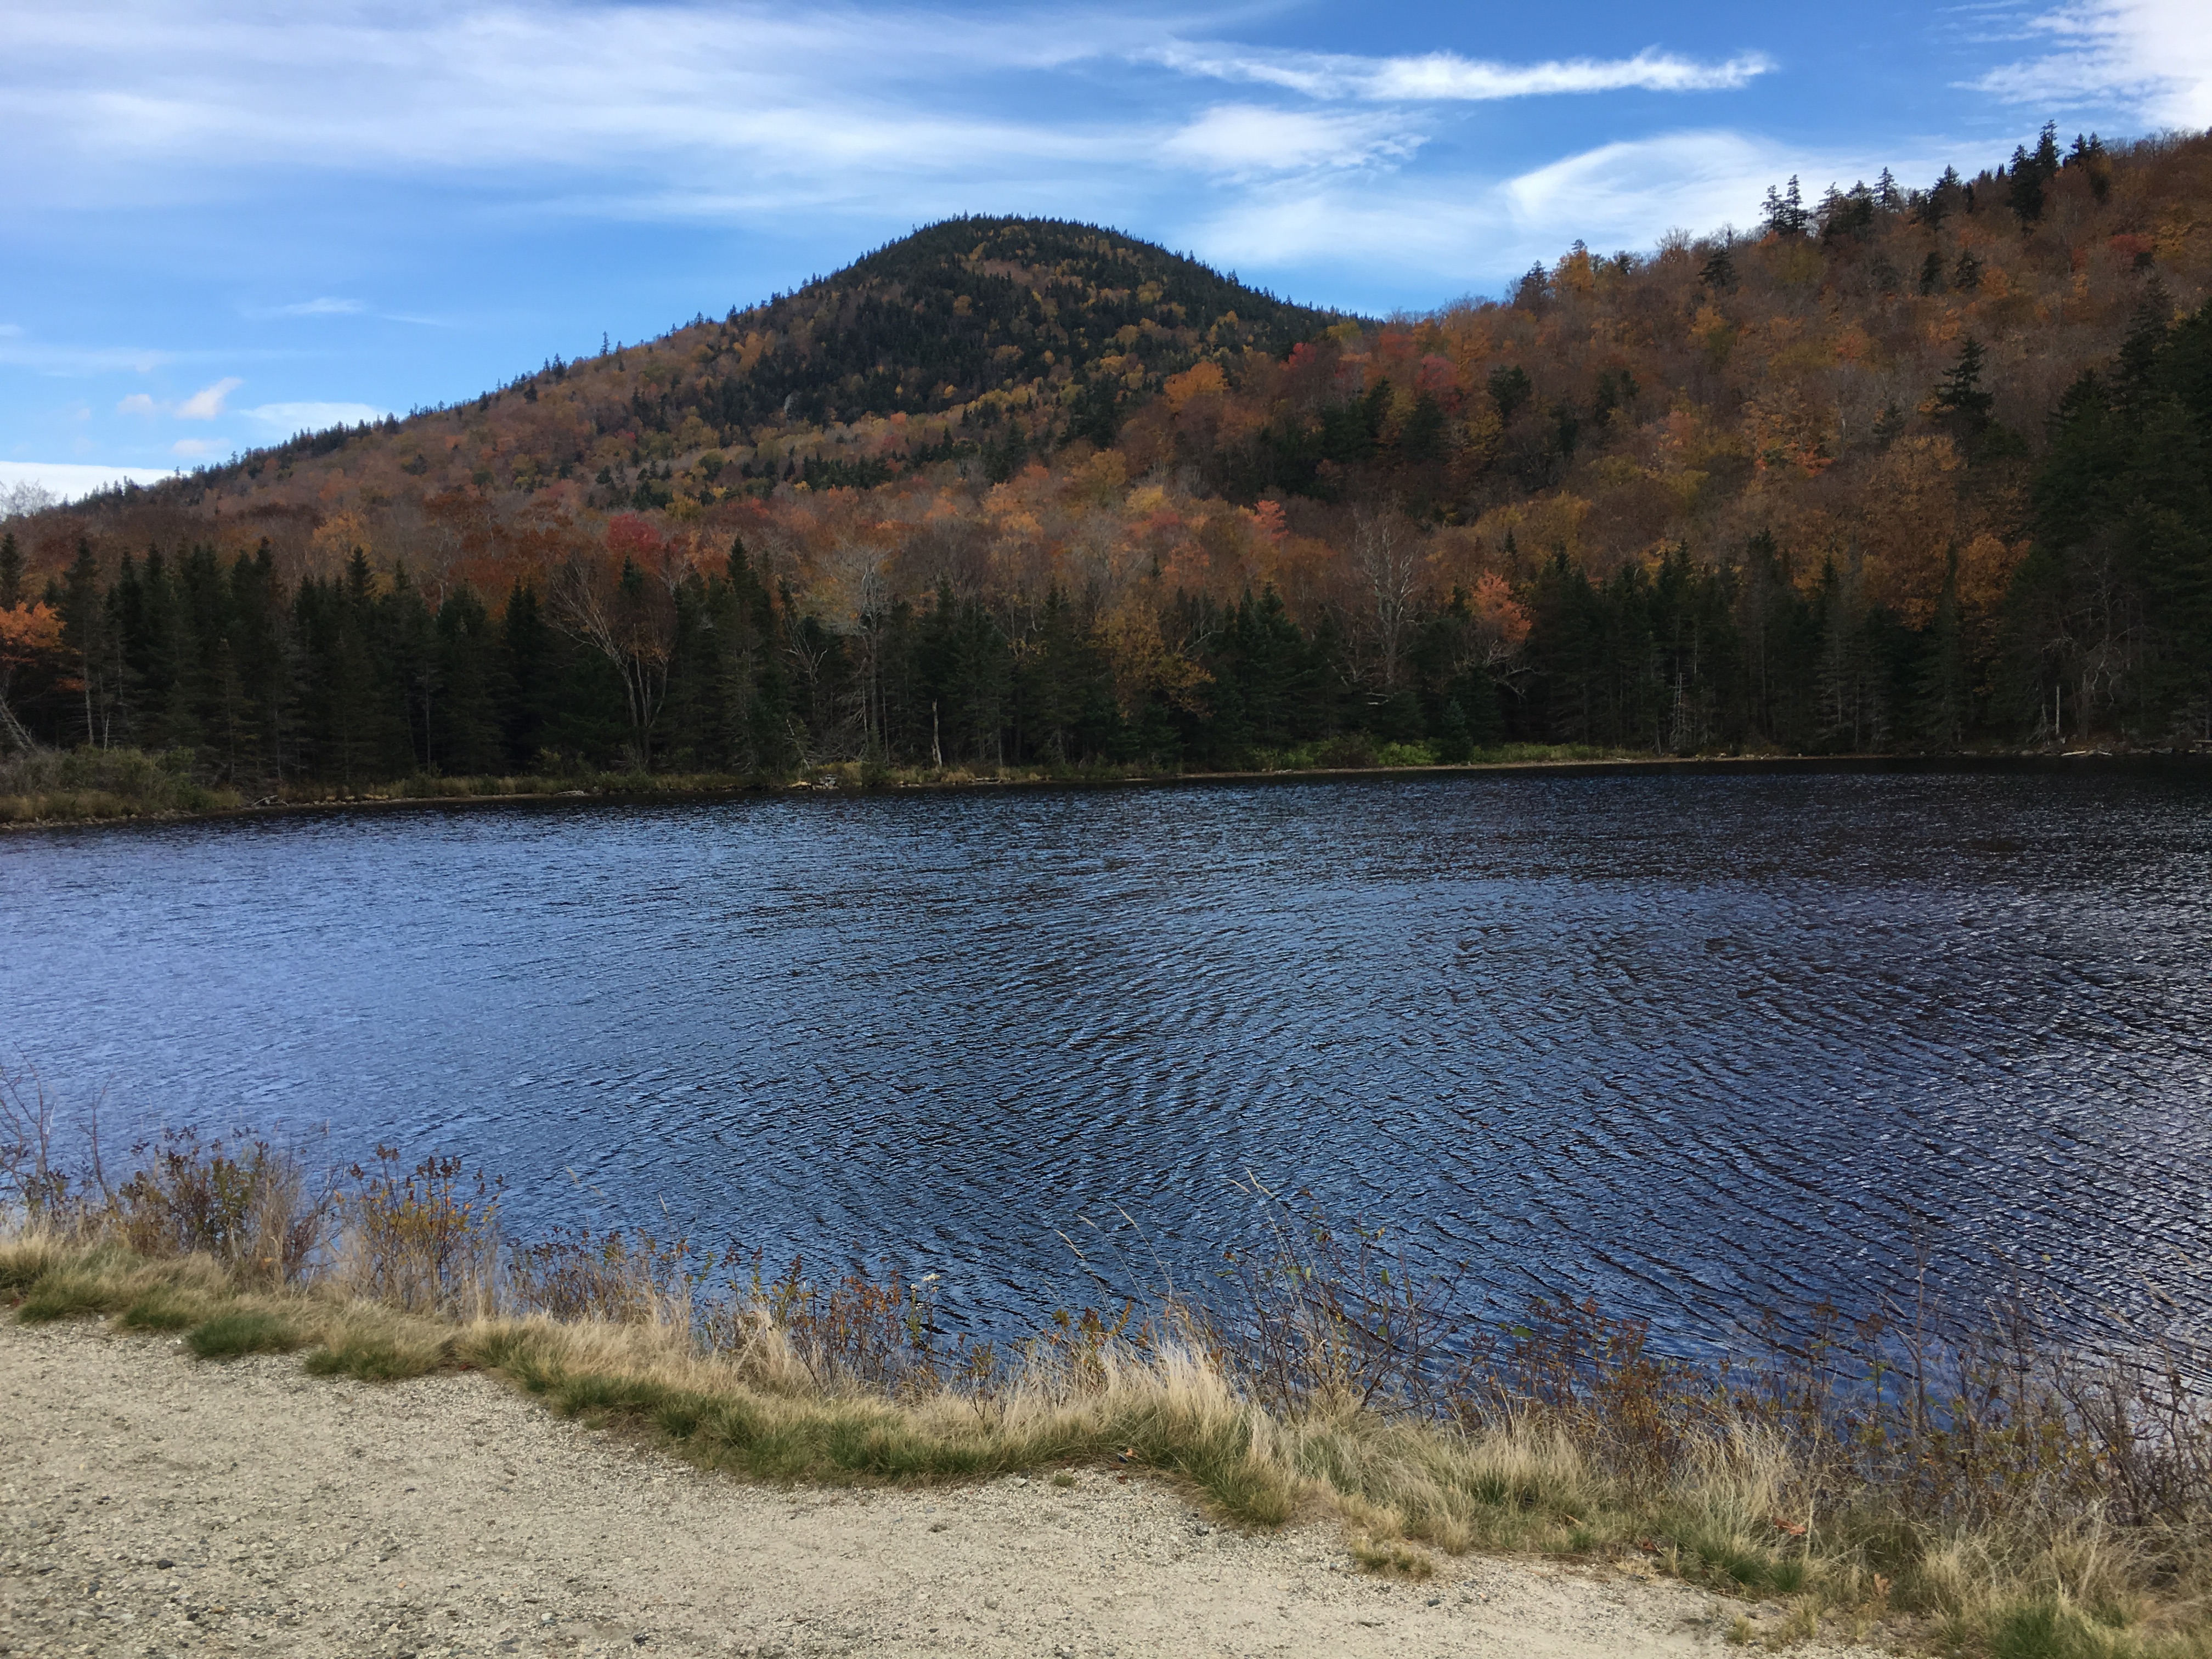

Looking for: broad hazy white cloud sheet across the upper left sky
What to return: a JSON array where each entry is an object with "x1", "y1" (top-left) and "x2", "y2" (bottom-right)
[{"x1": 0, "y1": 0, "x2": 1157, "y2": 195}]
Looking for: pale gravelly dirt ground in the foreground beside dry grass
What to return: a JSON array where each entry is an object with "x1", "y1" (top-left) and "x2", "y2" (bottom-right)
[{"x1": 0, "y1": 1323, "x2": 1876, "y2": 1659}]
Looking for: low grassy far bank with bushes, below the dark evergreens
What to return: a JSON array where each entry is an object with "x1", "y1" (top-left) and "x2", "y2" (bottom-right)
[{"x1": 0, "y1": 746, "x2": 2212, "y2": 830}]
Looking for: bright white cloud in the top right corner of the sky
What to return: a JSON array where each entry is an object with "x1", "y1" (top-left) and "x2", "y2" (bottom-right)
[{"x1": 1971, "y1": 0, "x2": 2212, "y2": 126}]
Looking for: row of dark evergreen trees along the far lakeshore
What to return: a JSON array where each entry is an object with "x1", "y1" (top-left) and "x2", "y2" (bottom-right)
[{"x1": 0, "y1": 294, "x2": 2212, "y2": 785}]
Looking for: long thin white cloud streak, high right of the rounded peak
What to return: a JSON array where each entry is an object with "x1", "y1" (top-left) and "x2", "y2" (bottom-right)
[{"x1": 1146, "y1": 44, "x2": 1774, "y2": 101}]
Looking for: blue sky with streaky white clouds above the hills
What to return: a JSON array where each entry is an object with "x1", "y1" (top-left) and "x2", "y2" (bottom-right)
[{"x1": 0, "y1": 0, "x2": 2212, "y2": 493}]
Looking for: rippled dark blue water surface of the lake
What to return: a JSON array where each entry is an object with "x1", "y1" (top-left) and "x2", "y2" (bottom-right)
[{"x1": 0, "y1": 776, "x2": 2212, "y2": 1340}]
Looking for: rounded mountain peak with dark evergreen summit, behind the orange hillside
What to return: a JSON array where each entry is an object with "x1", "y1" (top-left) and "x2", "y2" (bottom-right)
[{"x1": 99, "y1": 219, "x2": 1340, "y2": 511}]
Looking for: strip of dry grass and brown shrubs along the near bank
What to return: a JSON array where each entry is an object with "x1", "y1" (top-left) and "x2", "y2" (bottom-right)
[{"x1": 0, "y1": 1095, "x2": 2212, "y2": 1659}]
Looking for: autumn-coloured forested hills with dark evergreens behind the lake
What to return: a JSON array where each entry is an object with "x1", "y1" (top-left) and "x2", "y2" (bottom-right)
[{"x1": 0, "y1": 128, "x2": 2212, "y2": 781}]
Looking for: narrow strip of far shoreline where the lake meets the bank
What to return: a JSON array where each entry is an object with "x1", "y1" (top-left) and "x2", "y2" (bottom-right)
[{"x1": 0, "y1": 750, "x2": 2212, "y2": 834}]
